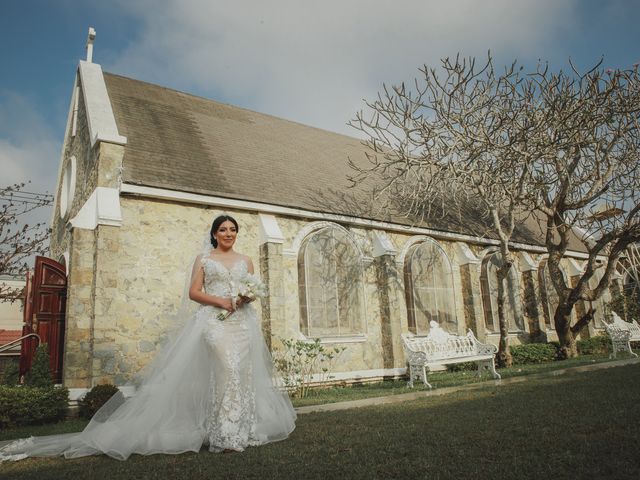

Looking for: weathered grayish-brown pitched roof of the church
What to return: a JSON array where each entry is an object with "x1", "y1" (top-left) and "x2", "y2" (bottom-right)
[{"x1": 104, "y1": 73, "x2": 582, "y2": 250}]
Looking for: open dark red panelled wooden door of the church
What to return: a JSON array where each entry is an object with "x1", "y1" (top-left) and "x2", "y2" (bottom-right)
[{"x1": 20, "y1": 257, "x2": 67, "y2": 383}]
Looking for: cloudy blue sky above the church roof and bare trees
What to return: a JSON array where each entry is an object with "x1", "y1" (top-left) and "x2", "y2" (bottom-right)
[{"x1": 0, "y1": 0, "x2": 640, "y2": 220}]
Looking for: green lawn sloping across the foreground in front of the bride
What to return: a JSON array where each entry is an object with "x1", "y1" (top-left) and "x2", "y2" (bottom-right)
[{"x1": 0, "y1": 363, "x2": 640, "y2": 480}]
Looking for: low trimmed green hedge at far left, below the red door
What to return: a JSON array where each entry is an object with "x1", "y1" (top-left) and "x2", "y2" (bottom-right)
[{"x1": 0, "y1": 385, "x2": 69, "y2": 428}]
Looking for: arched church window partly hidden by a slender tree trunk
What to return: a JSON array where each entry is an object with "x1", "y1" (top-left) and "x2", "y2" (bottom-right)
[{"x1": 480, "y1": 252, "x2": 524, "y2": 333}]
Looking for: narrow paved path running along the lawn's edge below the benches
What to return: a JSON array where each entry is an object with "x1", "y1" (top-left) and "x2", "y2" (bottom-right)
[{"x1": 296, "y1": 358, "x2": 640, "y2": 415}]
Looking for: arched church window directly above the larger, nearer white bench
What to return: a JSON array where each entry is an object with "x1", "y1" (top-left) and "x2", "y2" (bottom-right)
[{"x1": 404, "y1": 240, "x2": 458, "y2": 334}]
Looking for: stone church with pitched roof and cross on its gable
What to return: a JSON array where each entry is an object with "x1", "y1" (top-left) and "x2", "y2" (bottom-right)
[{"x1": 35, "y1": 37, "x2": 607, "y2": 398}]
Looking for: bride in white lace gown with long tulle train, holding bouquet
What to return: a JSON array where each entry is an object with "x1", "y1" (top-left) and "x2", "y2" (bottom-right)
[{"x1": 0, "y1": 215, "x2": 296, "y2": 461}]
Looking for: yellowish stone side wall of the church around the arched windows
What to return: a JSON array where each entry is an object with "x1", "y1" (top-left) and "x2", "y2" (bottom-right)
[{"x1": 65, "y1": 191, "x2": 612, "y2": 387}]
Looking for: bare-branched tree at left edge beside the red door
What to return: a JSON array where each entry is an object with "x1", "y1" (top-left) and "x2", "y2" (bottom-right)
[{"x1": 0, "y1": 183, "x2": 52, "y2": 302}]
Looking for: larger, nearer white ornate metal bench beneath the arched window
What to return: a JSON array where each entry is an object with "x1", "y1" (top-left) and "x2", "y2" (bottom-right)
[{"x1": 402, "y1": 321, "x2": 500, "y2": 388}]
